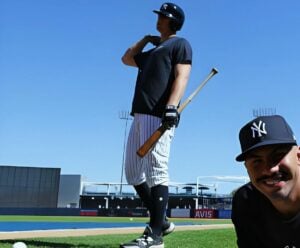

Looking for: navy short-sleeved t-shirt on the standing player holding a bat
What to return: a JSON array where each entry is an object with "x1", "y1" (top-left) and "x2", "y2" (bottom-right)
[{"x1": 131, "y1": 36, "x2": 192, "y2": 117}]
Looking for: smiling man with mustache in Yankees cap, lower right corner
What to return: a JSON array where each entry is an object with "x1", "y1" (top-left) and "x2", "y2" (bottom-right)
[{"x1": 232, "y1": 115, "x2": 300, "y2": 248}]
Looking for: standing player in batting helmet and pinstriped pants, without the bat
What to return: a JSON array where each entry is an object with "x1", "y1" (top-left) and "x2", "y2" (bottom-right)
[{"x1": 120, "y1": 3, "x2": 192, "y2": 248}]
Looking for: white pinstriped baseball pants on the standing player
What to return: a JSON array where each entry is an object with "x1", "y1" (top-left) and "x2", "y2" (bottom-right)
[{"x1": 125, "y1": 114, "x2": 175, "y2": 187}]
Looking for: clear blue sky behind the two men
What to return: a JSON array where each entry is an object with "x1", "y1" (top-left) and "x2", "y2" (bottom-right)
[{"x1": 0, "y1": 0, "x2": 300, "y2": 192}]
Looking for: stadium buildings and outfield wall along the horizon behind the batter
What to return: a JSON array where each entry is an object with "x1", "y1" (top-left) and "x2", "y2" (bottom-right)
[{"x1": 0, "y1": 166, "x2": 237, "y2": 218}]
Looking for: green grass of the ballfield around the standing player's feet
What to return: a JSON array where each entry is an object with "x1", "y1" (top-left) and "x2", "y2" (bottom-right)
[{"x1": 0, "y1": 216, "x2": 237, "y2": 248}]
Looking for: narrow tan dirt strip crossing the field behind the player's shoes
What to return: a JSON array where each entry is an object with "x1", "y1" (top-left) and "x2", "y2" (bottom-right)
[{"x1": 0, "y1": 224, "x2": 233, "y2": 240}]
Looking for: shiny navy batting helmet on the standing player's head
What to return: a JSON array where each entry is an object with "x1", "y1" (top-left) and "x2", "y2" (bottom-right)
[{"x1": 153, "y1": 3, "x2": 184, "y2": 31}]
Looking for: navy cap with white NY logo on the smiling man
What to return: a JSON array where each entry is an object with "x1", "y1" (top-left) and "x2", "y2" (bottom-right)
[{"x1": 236, "y1": 115, "x2": 297, "y2": 162}]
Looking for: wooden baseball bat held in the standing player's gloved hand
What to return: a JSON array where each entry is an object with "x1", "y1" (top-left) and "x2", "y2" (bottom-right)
[{"x1": 136, "y1": 68, "x2": 218, "y2": 158}]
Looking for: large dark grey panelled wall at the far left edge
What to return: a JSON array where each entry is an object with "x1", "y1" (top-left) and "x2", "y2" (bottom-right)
[{"x1": 0, "y1": 166, "x2": 60, "y2": 208}]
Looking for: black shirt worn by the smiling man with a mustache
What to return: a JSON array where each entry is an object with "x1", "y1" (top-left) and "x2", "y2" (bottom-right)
[{"x1": 232, "y1": 183, "x2": 300, "y2": 248}]
